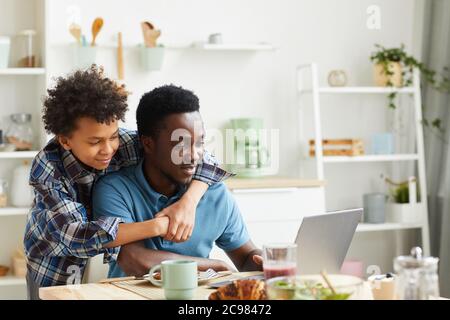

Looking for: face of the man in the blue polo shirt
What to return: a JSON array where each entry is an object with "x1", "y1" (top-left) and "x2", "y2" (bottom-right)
[{"x1": 147, "y1": 112, "x2": 205, "y2": 185}]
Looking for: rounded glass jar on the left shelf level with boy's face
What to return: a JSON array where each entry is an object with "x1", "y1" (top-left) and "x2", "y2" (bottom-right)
[{"x1": 6, "y1": 113, "x2": 34, "y2": 151}]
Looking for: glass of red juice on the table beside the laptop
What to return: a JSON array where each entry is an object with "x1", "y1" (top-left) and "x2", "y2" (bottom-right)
[{"x1": 263, "y1": 243, "x2": 297, "y2": 280}]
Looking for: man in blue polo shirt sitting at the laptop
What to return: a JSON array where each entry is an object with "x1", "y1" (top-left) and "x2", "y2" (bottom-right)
[{"x1": 93, "y1": 85, "x2": 262, "y2": 277}]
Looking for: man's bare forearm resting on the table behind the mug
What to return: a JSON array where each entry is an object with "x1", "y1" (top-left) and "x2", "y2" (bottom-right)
[{"x1": 117, "y1": 241, "x2": 234, "y2": 276}]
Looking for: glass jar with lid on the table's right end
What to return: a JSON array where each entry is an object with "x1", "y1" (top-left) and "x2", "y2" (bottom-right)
[{"x1": 394, "y1": 247, "x2": 439, "y2": 300}]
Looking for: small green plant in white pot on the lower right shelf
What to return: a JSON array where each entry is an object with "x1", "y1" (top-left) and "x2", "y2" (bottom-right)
[{"x1": 385, "y1": 177, "x2": 425, "y2": 223}]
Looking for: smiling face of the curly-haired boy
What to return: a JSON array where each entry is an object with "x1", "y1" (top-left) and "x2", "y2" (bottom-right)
[{"x1": 59, "y1": 117, "x2": 119, "y2": 170}]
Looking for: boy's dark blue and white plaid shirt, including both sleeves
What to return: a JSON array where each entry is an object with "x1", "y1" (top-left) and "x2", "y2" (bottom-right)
[{"x1": 24, "y1": 129, "x2": 232, "y2": 287}]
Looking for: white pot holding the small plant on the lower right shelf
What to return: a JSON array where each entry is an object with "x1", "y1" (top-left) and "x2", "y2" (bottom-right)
[{"x1": 386, "y1": 203, "x2": 425, "y2": 223}]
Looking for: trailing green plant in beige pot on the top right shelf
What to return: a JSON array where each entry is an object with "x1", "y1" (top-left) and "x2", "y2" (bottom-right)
[{"x1": 370, "y1": 44, "x2": 450, "y2": 130}]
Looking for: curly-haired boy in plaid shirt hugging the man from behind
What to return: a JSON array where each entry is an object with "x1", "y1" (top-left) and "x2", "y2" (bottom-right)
[{"x1": 24, "y1": 66, "x2": 228, "y2": 299}]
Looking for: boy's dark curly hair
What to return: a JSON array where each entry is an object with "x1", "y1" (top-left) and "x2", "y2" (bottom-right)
[{"x1": 42, "y1": 64, "x2": 129, "y2": 136}]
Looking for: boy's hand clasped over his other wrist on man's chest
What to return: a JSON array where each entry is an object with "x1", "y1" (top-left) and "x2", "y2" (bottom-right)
[{"x1": 155, "y1": 197, "x2": 197, "y2": 242}]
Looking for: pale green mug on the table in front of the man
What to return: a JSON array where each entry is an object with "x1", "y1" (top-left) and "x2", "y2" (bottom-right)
[{"x1": 149, "y1": 260, "x2": 198, "y2": 300}]
